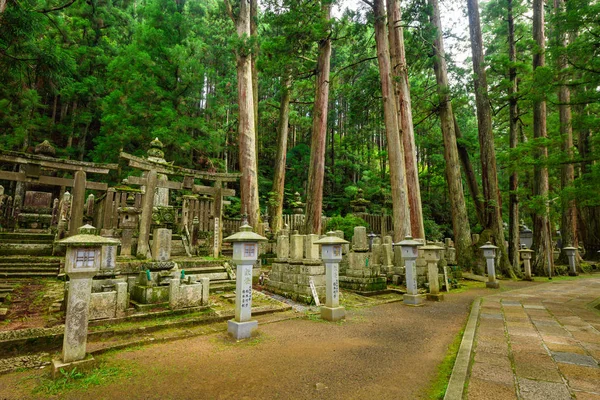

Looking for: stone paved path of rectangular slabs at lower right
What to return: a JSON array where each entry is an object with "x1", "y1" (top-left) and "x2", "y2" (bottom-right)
[{"x1": 467, "y1": 278, "x2": 600, "y2": 400}]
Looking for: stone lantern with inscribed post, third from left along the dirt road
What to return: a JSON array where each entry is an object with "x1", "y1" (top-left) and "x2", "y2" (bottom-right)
[{"x1": 314, "y1": 232, "x2": 349, "y2": 321}]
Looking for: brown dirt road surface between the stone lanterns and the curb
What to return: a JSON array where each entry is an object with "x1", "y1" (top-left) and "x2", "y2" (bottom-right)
[{"x1": 0, "y1": 281, "x2": 535, "y2": 399}]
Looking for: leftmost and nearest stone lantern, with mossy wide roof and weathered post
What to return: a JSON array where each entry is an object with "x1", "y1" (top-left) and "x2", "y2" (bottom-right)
[{"x1": 52, "y1": 225, "x2": 119, "y2": 377}]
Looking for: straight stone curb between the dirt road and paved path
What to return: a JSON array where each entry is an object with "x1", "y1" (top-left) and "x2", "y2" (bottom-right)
[{"x1": 444, "y1": 297, "x2": 481, "y2": 400}]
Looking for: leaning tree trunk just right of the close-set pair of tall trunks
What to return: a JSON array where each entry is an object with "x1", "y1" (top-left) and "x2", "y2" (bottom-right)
[{"x1": 429, "y1": 0, "x2": 474, "y2": 269}]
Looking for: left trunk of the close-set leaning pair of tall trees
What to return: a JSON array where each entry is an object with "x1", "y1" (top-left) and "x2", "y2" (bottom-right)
[{"x1": 373, "y1": 0, "x2": 412, "y2": 242}]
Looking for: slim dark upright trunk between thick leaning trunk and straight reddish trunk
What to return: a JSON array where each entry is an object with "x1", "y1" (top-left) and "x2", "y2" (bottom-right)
[{"x1": 507, "y1": 0, "x2": 521, "y2": 269}]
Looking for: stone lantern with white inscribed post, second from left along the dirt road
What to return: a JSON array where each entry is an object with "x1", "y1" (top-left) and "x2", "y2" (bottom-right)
[{"x1": 223, "y1": 221, "x2": 267, "y2": 340}]
